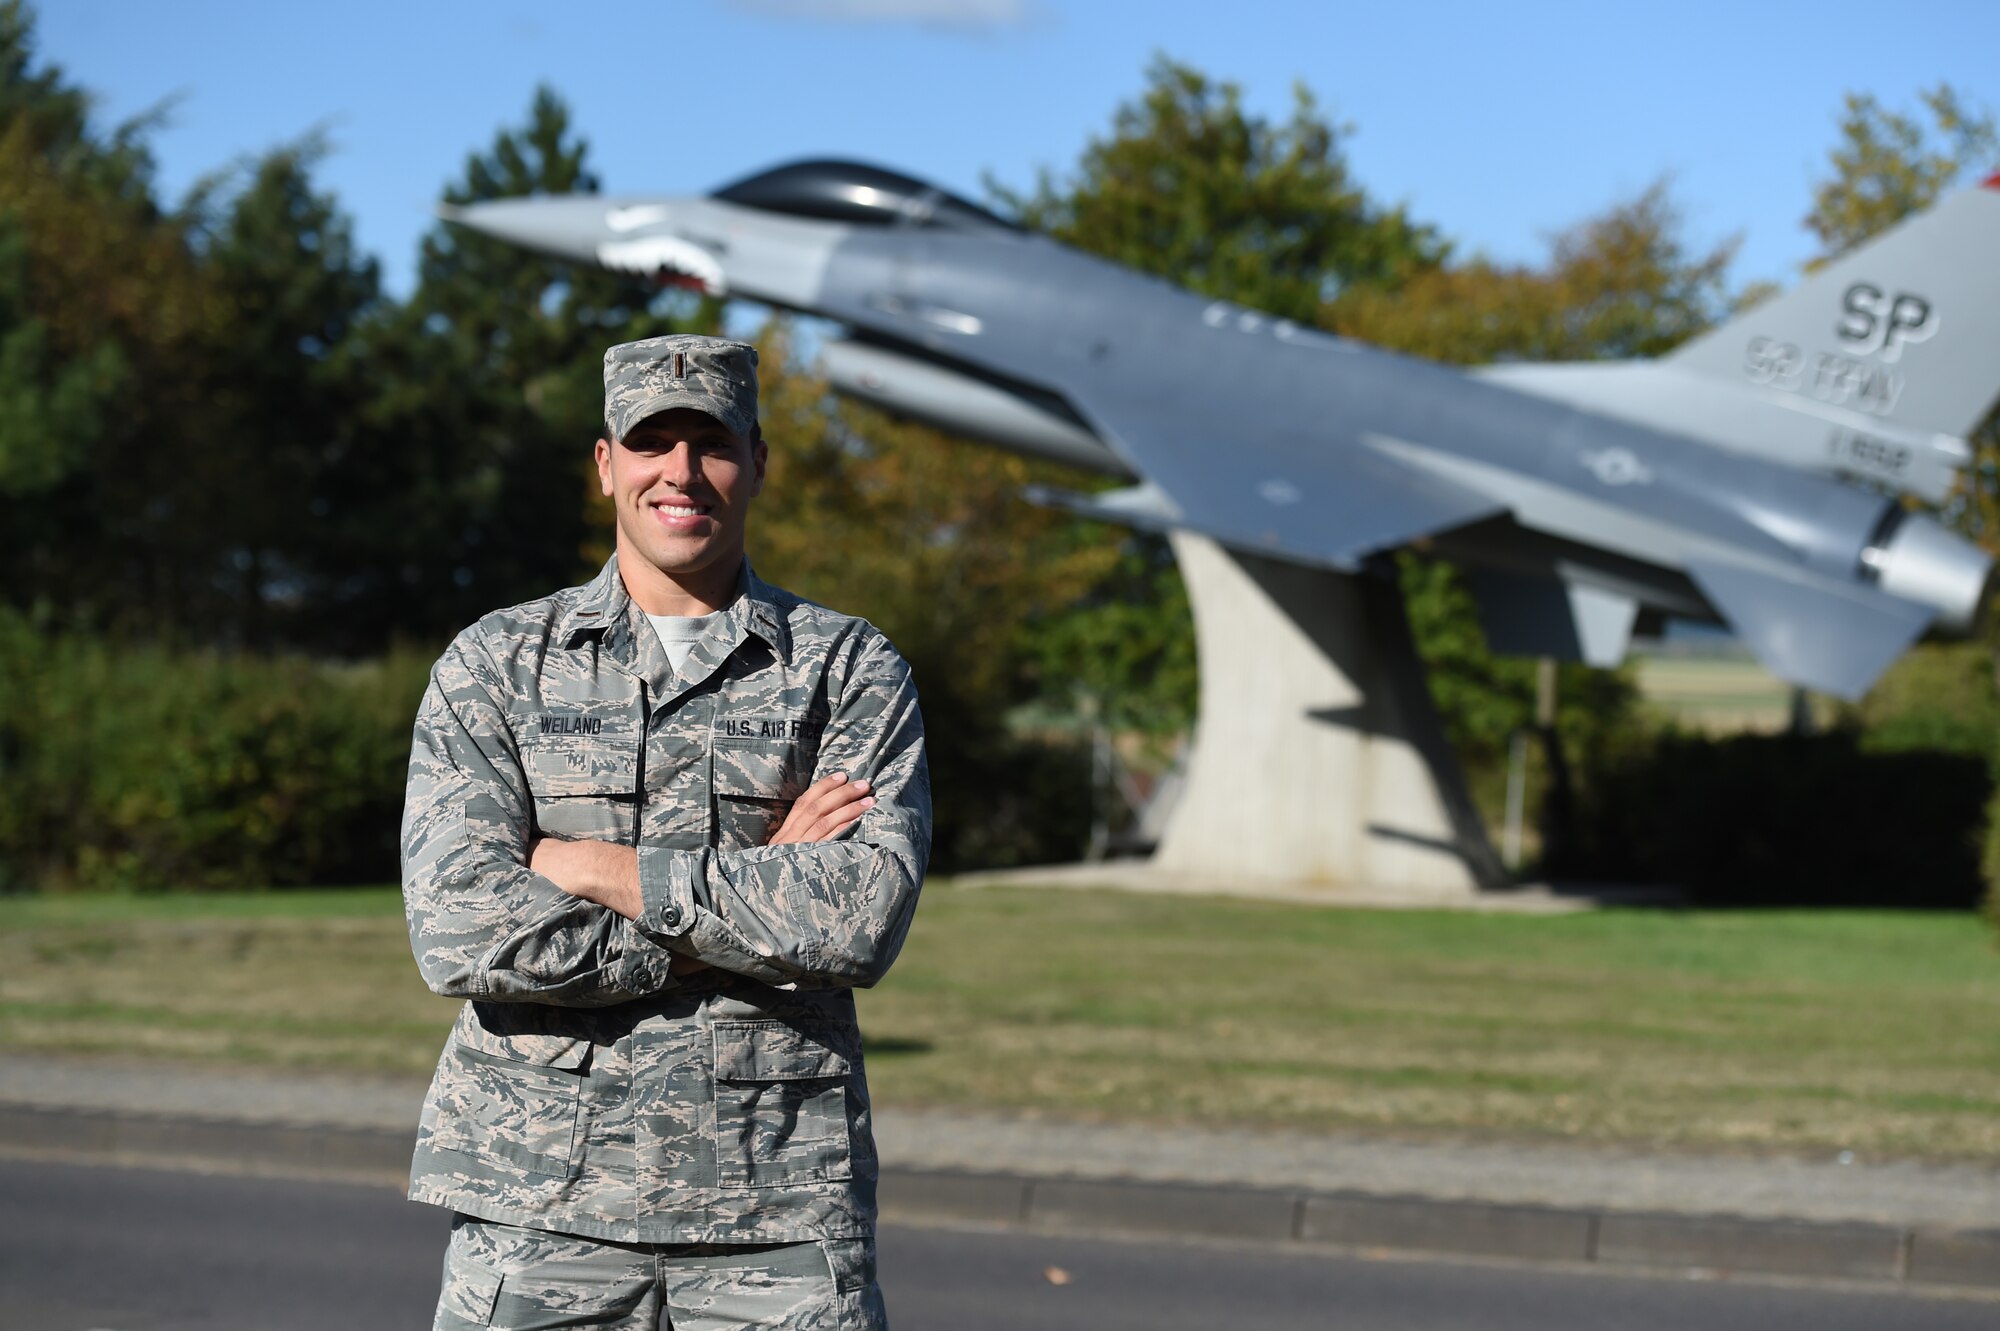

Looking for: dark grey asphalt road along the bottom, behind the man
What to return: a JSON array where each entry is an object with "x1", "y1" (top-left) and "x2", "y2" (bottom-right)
[{"x1": 0, "y1": 1161, "x2": 2000, "y2": 1331}]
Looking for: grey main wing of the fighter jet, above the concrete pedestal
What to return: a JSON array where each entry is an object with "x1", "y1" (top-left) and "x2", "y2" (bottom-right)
[{"x1": 1064, "y1": 391, "x2": 1506, "y2": 570}]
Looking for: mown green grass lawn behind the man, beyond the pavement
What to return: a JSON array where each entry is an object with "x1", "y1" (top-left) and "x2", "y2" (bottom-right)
[{"x1": 0, "y1": 883, "x2": 2000, "y2": 1157}]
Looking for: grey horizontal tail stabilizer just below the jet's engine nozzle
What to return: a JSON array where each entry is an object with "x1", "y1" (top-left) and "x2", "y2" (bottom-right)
[{"x1": 1688, "y1": 562, "x2": 1934, "y2": 701}]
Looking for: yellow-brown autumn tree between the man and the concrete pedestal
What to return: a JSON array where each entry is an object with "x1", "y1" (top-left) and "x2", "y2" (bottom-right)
[{"x1": 752, "y1": 324, "x2": 1118, "y2": 871}]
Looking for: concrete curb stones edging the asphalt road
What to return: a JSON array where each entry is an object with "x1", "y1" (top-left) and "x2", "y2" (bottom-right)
[{"x1": 0, "y1": 1105, "x2": 2000, "y2": 1291}]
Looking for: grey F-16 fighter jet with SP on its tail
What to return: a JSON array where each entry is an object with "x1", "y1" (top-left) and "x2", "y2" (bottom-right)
[{"x1": 446, "y1": 162, "x2": 2000, "y2": 697}]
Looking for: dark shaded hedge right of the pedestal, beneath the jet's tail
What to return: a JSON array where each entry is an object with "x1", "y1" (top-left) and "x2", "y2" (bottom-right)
[{"x1": 1546, "y1": 644, "x2": 2000, "y2": 923}]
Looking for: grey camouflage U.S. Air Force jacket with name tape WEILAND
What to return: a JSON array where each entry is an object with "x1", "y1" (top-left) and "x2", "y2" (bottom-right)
[{"x1": 402, "y1": 558, "x2": 930, "y2": 1243}]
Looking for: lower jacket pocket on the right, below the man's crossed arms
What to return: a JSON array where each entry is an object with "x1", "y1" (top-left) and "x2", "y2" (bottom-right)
[{"x1": 716, "y1": 1021, "x2": 854, "y2": 1187}]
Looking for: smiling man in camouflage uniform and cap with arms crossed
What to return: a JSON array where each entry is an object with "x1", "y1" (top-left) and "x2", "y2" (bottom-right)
[{"x1": 402, "y1": 336, "x2": 930, "y2": 1331}]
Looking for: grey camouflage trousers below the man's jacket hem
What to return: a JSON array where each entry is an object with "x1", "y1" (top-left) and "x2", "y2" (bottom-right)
[{"x1": 434, "y1": 1215, "x2": 888, "y2": 1331}]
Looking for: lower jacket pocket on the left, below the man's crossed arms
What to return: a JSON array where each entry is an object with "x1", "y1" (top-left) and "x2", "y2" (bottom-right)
[{"x1": 434, "y1": 1045, "x2": 584, "y2": 1177}]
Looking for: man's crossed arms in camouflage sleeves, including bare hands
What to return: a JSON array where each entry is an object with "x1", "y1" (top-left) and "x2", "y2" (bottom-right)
[{"x1": 404, "y1": 632, "x2": 930, "y2": 1007}]
